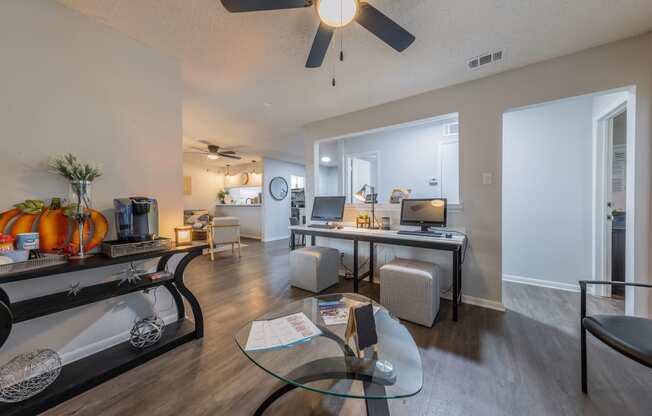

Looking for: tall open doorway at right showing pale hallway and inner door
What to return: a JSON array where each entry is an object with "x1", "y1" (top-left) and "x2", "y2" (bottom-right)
[{"x1": 502, "y1": 90, "x2": 636, "y2": 313}]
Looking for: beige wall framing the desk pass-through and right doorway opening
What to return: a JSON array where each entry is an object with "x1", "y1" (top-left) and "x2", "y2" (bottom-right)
[{"x1": 305, "y1": 34, "x2": 652, "y2": 313}]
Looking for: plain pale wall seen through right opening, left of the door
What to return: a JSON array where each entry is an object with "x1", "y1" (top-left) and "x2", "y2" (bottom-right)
[{"x1": 502, "y1": 97, "x2": 593, "y2": 289}]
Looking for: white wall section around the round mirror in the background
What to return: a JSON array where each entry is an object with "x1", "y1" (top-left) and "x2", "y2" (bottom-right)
[{"x1": 263, "y1": 159, "x2": 306, "y2": 241}]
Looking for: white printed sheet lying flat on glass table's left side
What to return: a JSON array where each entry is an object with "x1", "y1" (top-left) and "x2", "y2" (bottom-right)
[{"x1": 245, "y1": 312, "x2": 321, "y2": 351}]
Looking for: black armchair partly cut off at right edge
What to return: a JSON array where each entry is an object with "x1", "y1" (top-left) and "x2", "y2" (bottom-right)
[{"x1": 579, "y1": 280, "x2": 652, "y2": 394}]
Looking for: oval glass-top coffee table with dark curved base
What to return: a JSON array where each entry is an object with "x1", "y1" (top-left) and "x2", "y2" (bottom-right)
[{"x1": 235, "y1": 293, "x2": 423, "y2": 416}]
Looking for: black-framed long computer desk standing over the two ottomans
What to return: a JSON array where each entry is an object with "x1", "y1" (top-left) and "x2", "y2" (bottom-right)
[{"x1": 290, "y1": 228, "x2": 464, "y2": 322}]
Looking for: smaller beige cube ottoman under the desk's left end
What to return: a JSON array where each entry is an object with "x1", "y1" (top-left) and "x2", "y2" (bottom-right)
[{"x1": 290, "y1": 246, "x2": 340, "y2": 293}]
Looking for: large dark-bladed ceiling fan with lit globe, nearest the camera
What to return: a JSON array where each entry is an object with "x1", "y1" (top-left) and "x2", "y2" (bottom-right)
[{"x1": 221, "y1": 0, "x2": 415, "y2": 68}]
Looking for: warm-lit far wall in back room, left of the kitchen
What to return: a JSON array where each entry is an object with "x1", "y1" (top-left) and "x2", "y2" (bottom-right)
[{"x1": 183, "y1": 161, "x2": 224, "y2": 212}]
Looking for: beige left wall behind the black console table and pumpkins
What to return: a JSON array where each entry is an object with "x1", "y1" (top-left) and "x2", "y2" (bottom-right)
[{"x1": 0, "y1": 0, "x2": 183, "y2": 363}]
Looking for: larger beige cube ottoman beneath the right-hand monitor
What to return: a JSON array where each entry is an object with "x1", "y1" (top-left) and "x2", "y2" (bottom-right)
[{"x1": 380, "y1": 259, "x2": 439, "y2": 327}]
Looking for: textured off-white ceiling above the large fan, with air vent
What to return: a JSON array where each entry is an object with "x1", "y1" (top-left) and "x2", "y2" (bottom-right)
[{"x1": 58, "y1": 0, "x2": 652, "y2": 161}]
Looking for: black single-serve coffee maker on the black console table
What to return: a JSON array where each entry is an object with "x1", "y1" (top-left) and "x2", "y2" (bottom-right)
[{"x1": 113, "y1": 196, "x2": 158, "y2": 243}]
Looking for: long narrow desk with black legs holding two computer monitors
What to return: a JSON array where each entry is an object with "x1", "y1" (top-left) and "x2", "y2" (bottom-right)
[{"x1": 290, "y1": 225, "x2": 466, "y2": 321}]
